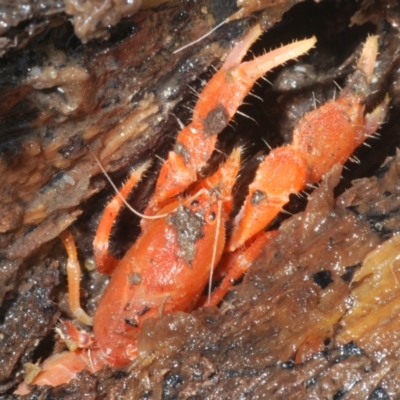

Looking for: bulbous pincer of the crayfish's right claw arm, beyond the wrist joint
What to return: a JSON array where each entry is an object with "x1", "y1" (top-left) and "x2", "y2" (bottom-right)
[{"x1": 293, "y1": 36, "x2": 386, "y2": 183}]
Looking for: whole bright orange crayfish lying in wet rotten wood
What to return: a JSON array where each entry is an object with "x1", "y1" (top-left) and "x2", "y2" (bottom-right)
[{"x1": 18, "y1": 21, "x2": 388, "y2": 394}]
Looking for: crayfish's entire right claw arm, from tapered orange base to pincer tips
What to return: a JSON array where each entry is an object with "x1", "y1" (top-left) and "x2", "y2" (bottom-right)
[{"x1": 228, "y1": 36, "x2": 389, "y2": 251}]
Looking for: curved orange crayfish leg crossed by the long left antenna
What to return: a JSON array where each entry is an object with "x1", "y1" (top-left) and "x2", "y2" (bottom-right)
[{"x1": 93, "y1": 163, "x2": 149, "y2": 275}]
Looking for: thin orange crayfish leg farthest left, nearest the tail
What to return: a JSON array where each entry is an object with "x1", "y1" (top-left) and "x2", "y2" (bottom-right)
[{"x1": 61, "y1": 230, "x2": 93, "y2": 325}]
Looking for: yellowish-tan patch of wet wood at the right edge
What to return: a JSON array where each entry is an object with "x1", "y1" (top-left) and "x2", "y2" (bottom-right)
[{"x1": 337, "y1": 235, "x2": 400, "y2": 348}]
